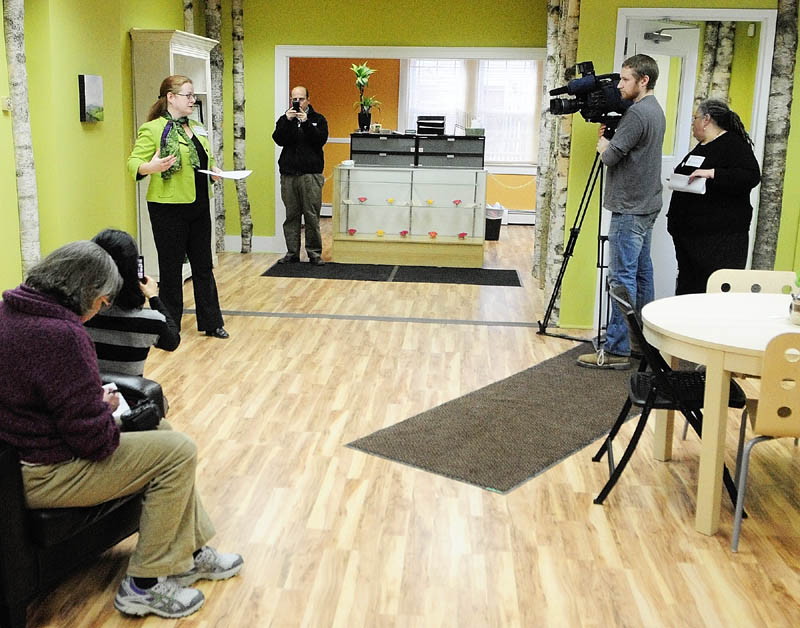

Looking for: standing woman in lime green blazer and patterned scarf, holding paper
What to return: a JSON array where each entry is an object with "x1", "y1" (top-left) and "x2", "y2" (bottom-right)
[{"x1": 128, "y1": 74, "x2": 228, "y2": 338}]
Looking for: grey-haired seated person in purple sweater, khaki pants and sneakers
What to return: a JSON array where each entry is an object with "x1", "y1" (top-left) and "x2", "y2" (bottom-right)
[{"x1": 0, "y1": 241, "x2": 243, "y2": 617}]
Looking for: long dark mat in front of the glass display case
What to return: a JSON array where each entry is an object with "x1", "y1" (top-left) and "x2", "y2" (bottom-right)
[{"x1": 261, "y1": 262, "x2": 521, "y2": 287}]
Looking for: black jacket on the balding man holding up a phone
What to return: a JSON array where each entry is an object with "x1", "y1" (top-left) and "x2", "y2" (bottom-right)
[{"x1": 272, "y1": 105, "x2": 328, "y2": 175}]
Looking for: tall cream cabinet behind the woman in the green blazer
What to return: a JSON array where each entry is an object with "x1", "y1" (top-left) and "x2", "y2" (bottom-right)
[{"x1": 130, "y1": 28, "x2": 217, "y2": 279}]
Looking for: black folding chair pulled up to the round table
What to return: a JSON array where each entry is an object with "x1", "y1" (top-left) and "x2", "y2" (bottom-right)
[{"x1": 592, "y1": 285, "x2": 745, "y2": 504}]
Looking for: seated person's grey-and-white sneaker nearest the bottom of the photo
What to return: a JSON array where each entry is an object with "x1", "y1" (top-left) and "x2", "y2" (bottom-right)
[{"x1": 114, "y1": 576, "x2": 205, "y2": 618}]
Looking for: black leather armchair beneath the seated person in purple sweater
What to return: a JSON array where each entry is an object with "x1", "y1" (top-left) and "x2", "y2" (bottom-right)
[{"x1": 0, "y1": 374, "x2": 163, "y2": 628}]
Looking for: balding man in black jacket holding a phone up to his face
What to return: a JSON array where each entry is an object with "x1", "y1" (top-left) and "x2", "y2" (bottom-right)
[{"x1": 272, "y1": 85, "x2": 328, "y2": 266}]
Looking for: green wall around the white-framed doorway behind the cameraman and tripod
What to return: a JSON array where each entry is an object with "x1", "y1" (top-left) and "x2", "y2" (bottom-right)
[{"x1": 559, "y1": 0, "x2": 800, "y2": 328}]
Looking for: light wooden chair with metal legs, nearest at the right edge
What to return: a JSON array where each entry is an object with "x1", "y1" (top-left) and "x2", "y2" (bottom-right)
[{"x1": 731, "y1": 333, "x2": 800, "y2": 552}]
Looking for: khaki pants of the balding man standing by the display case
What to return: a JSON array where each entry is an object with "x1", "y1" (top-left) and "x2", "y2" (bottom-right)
[{"x1": 281, "y1": 174, "x2": 325, "y2": 259}]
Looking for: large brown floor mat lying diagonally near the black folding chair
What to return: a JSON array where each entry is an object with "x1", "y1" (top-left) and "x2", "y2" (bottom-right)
[{"x1": 347, "y1": 344, "x2": 631, "y2": 493}]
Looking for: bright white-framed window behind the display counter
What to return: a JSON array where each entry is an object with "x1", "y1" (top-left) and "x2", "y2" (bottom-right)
[{"x1": 401, "y1": 59, "x2": 542, "y2": 164}]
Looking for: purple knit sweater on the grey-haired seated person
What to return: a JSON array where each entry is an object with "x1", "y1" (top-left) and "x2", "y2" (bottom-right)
[{"x1": 0, "y1": 284, "x2": 119, "y2": 464}]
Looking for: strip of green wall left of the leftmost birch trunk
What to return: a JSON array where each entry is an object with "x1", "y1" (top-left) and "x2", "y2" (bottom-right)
[{"x1": 0, "y1": 11, "x2": 22, "y2": 292}]
